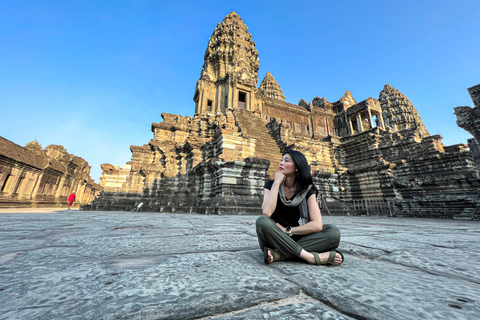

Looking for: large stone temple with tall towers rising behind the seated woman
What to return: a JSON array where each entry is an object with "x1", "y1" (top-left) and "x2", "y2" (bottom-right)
[{"x1": 91, "y1": 12, "x2": 480, "y2": 218}]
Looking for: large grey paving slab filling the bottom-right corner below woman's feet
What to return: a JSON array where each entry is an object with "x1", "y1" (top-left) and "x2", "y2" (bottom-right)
[{"x1": 285, "y1": 255, "x2": 480, "y2": 319}]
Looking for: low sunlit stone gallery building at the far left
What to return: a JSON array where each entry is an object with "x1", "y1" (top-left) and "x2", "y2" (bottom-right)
[{"x1": 0, "y1": 137, "x2": 103, "y2": 207}]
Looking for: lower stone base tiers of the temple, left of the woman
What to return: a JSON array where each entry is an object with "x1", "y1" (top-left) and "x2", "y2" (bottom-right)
[{"x1": 92, "y1": 158, "x2": 269, "y2": 214}]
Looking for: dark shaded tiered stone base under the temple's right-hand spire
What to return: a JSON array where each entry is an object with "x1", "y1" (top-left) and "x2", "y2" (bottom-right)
[{"x1": 336, "y1": 128, "x2": 480, "y2": 218}]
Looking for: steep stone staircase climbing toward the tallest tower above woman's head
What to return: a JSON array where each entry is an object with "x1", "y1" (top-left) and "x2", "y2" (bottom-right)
[{"x1": 233, "y1": 109, "x2": 282, "y2": 179}]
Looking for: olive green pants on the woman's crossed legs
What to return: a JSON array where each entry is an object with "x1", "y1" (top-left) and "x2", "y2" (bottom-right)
[{"x1": 256, "y1": 215, "x2": 340, "y2": 259}]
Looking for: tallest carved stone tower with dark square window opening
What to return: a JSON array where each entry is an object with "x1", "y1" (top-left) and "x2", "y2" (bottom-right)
[{"x1": 193, "y1": 12, "x2": 259, "y2": 114}]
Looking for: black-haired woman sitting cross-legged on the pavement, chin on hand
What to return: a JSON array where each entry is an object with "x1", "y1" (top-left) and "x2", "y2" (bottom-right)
[{"x1": 256, "y1": 150, "x2": 344, "y2": 266}]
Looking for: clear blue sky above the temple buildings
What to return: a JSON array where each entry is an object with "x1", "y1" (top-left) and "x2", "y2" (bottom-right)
[{"x1": 0, "y1": 0, "x2": 480, "y2": 182}]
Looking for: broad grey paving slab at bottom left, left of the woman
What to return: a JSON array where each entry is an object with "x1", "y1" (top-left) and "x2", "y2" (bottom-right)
[{"x1": 0, "y1": 251, "x2": 299, "y2": 319}]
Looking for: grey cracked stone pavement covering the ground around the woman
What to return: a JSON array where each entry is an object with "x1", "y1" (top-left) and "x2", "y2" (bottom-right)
[{"x1": 0, "y1": 209, "x2": 480, "y2": 320}]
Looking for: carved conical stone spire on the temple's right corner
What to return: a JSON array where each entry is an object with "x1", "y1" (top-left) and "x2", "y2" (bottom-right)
[{"x1": 379, "y1": 84, "x2": 430, "y2": 138}]
